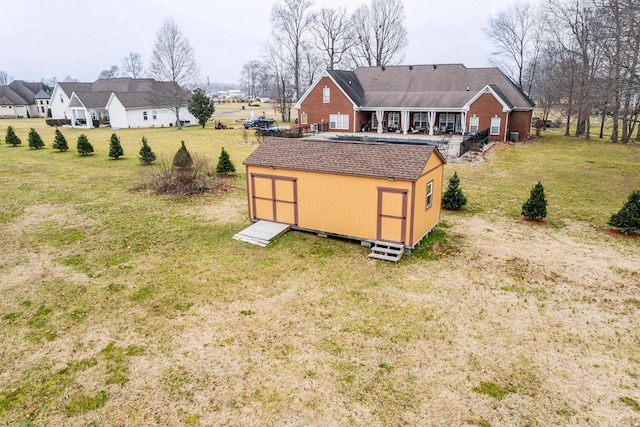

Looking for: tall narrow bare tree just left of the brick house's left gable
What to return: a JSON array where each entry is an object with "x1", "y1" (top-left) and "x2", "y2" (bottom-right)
[{"x1": 271, "y1": 0, "x2": 314, "y2": 99}]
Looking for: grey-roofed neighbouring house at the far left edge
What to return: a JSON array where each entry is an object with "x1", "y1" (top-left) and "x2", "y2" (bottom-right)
[{"x1": 0, "y1": 80, "x2": 49, "y2": 118}]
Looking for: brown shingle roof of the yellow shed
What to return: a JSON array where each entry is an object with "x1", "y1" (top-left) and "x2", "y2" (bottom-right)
[{"x1": 243, "y1": 138, "x2": 444, "y2": 181}]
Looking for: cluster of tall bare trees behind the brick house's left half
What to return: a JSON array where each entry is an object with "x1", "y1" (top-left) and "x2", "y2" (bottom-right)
[{"x1": 240, "y1": 0, "x2": 408, "y2": 122}]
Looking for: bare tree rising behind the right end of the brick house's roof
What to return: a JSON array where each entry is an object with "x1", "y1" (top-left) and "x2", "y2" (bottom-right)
[{"x1": 484, "y1": 2, "x2": 545, "y2": 94}]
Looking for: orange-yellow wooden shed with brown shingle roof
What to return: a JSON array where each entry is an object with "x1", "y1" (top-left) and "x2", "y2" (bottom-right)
[{"x1": 243, "y1": 138, "x2": 445, "y2": 253}]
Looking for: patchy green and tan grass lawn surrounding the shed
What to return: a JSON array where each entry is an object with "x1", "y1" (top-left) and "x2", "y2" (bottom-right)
[{"x1": 0, "y1": 118, "x2": 640, "y2": 426}]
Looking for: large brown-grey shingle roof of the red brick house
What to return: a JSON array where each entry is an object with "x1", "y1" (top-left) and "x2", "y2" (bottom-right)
[{"x1": 328, "y1": 64, "x2": 535, "y2": 109}]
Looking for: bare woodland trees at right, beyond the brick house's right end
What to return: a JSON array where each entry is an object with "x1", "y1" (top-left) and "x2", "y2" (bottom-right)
[{"x1": 485, "y1": 0, "x2": 640, "y2": 143}]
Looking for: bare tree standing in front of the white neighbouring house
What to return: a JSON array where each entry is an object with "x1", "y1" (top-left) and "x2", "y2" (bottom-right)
[{"x1": 151, "y1": 18, "x2": 198, "y2": 129}]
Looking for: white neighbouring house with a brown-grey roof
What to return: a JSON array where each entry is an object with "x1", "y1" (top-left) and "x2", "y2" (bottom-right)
[{"x1": 51, "y1": 77, "x2": 197, "y2": 128}]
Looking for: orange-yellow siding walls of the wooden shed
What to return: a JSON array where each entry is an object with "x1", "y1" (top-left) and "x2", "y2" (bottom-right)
[{"x1": 247, "y1": 154, "x2": 443, "y2": 246}]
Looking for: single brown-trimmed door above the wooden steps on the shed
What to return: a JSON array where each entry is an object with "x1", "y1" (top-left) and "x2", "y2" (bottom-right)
[{"x1": 378, "y1": 188, "x2": 407, "y2": 244}]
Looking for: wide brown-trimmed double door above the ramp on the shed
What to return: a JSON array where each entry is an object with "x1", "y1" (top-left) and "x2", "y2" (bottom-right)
[{"x1": 251, "y1": 174, "x2": 298, "y2": 225}]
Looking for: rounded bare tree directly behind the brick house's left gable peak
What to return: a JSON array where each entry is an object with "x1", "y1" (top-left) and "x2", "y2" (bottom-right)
[{"x1": 311, "y1": 7, "x2": 354, "y2": 70}]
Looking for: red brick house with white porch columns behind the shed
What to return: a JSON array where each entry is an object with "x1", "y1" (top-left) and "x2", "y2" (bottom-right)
[{"x1": 295, "y1": 64, "x2": 535, "y2": 141}]
